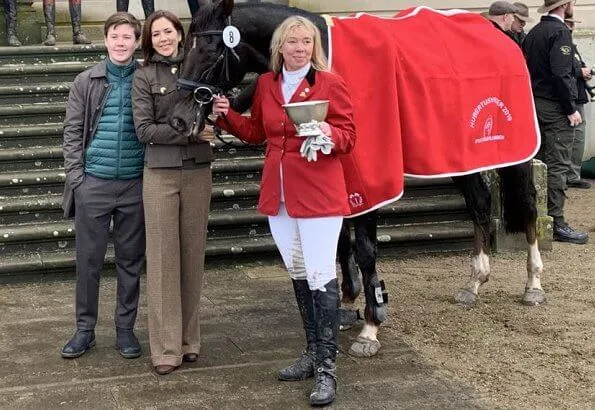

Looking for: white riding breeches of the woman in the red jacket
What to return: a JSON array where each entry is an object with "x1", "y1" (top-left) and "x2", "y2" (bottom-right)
[{"x1": 269, "y1": 202, "x2": 343, "y2": 290}]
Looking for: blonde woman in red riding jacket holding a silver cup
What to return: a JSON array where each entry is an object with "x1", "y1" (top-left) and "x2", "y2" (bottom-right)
[{"x1": 213, "y1": 16, "x2": 355, "y2": 405}]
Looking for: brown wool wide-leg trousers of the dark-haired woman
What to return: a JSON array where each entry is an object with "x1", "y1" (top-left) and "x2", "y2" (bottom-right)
[{"x1": 143, "y1": 167, "x2": 212, "y2": 366}]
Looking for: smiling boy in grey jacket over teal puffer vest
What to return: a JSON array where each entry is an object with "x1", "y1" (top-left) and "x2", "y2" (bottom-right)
[{"x1": 61, "y1": 12, "x2": 145, "y2": 358}]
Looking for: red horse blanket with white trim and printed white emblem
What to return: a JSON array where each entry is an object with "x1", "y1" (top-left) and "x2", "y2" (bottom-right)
[{"x1": 329, "y1": 7, "x2": 540, "y2": 216}]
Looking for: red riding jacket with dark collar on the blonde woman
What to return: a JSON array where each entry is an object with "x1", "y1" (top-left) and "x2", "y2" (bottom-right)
[{"x1": 217, "y1": 70, "x2": 355, "y2": 218}]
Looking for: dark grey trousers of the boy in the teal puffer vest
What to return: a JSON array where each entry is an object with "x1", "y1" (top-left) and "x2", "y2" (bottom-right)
[{"x1": 74, "y1": 175, "x2": 145, "y2": 330}]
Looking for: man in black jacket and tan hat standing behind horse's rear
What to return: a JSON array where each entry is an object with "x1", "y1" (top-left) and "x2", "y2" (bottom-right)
[{"x1": 523, "y1": 0, "x2": 589, "y2": 244}]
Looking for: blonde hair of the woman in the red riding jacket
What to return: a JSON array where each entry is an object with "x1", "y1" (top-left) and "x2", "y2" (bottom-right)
[{"x1": 271, "y1": 16, "x2": 328, "y2": 73}]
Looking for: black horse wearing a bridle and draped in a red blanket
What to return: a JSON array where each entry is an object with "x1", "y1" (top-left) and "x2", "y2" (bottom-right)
[{"x1": 171, "y1": 0, "x2": 545, "y2": 356}]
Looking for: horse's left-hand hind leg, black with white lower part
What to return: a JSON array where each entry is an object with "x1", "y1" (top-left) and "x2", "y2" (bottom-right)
[{"x1": 453, "y1": 173, "x2": 491, "y2": 306}]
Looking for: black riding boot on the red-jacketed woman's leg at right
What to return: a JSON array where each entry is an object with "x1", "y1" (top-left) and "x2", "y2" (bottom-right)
[{"x1": 310, "y1": 279, "x2": 339, "y2": 406}]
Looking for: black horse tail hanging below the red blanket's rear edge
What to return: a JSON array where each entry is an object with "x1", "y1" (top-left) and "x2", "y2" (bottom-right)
[{"x1": 498, "y1": 161, "x2": 537, "y2": 233}]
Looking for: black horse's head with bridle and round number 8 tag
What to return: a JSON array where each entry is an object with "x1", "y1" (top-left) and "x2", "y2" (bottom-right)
[{"x1": 170, "y1": 0, "x2": 247, "y2": 135}]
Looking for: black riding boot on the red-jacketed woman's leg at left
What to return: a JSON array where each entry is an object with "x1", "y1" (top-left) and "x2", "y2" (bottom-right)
[{"x1": 279, "y1": 279, "x2": 316, "y2": 381}]
